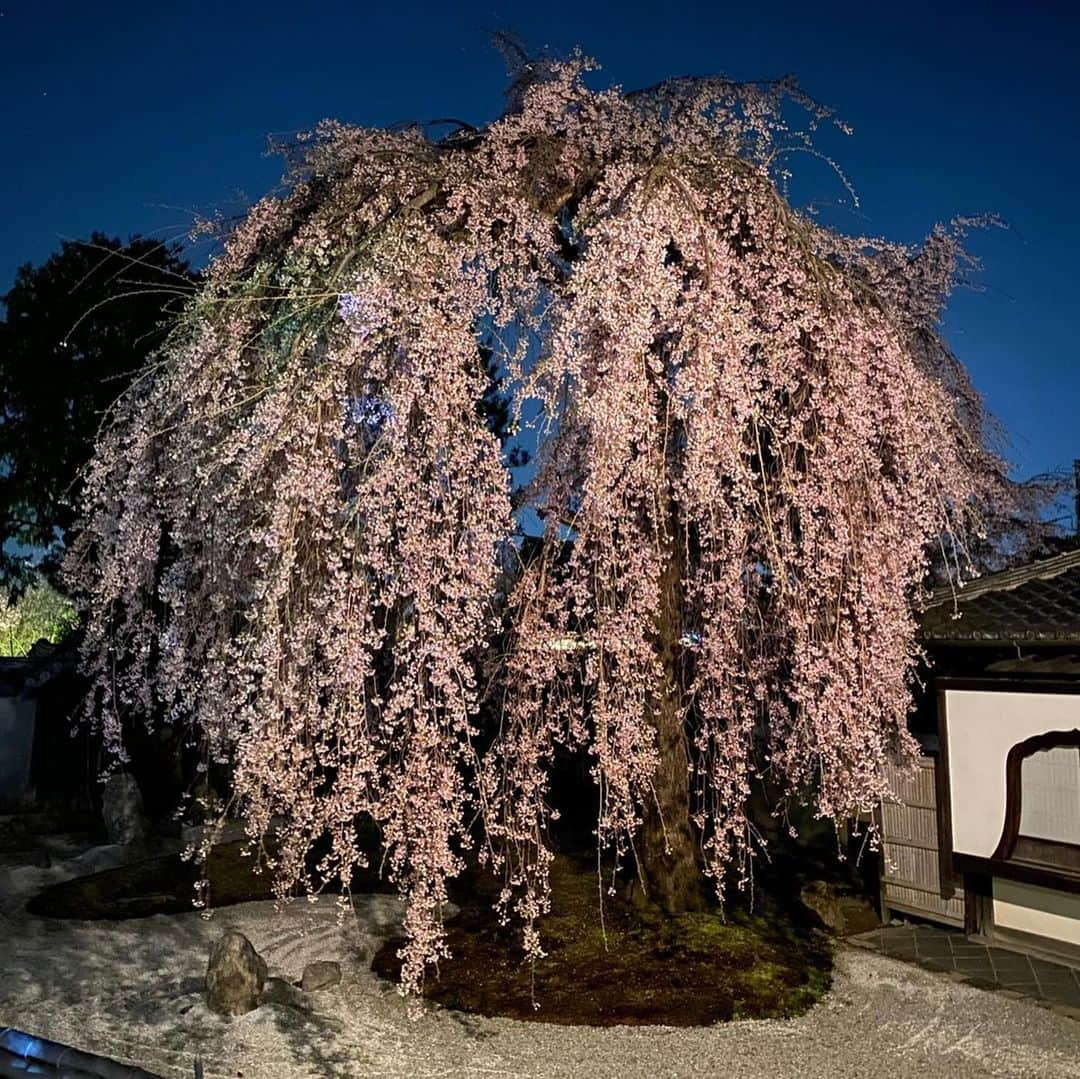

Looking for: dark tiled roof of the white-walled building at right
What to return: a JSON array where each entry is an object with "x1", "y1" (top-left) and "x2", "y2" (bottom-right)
[{"x1": 919, "y1": 551, "x2": 1080, "y2": 645}]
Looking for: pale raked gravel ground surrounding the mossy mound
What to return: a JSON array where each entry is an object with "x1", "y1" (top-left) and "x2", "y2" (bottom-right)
[{"x1": 0, "y1": 848, "x2": 1080, "y2": 1079}]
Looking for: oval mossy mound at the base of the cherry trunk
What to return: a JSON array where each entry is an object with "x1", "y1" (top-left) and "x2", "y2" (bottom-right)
[{"x1": 372, "y1": 857, "x2": 832, "y2": 1026}]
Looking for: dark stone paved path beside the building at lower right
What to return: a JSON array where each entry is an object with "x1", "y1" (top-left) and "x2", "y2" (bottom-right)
[{"x1": 848, "y1": 922, "x2": 1080, "y2": 1019}]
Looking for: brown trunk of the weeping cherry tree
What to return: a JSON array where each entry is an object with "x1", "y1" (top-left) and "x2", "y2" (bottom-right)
[{"x1": 637, "y1": 507, "x2": 705, "y2": 914}]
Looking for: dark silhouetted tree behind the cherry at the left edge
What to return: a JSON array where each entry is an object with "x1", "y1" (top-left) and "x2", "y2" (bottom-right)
[{"x1": 0, "y1": 232, "x2": 194, "y2": 588}]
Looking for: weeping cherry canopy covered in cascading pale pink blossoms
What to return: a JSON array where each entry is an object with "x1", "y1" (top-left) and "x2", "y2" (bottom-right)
[{"x1": 69, "y1": 58, "x2": 1003, "y2": 989}]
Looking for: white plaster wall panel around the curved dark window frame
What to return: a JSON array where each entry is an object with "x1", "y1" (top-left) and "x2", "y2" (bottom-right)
[{"x1": 945, "y1": 689, "x2": 1080, "y2": 858}]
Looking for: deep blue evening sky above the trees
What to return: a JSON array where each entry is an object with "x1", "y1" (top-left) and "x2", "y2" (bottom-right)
[{"x1": 6, "y1": 0, "x2": 1080, "y2": 501}]
